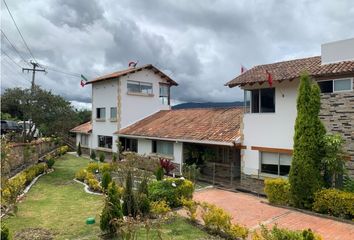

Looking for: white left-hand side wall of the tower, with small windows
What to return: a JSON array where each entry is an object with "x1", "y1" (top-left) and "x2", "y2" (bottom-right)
[{"x1": 91, "y1": 79, "x2": 118, "y2": 152}]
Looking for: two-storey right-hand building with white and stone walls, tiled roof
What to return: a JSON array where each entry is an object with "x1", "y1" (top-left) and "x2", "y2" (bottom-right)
[{"x1": 226, "y1": 39, "x2": 354, "y2": 189}]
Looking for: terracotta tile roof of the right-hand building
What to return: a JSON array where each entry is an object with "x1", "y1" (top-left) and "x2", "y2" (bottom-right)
[{"x1": 225, "y1": 56, "x2": 354, "y2": 87}]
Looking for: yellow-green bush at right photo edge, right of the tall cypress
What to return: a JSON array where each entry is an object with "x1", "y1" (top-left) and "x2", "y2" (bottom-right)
[{"x1": 312, "y1": 189, "x2": 354, "y2": 219}]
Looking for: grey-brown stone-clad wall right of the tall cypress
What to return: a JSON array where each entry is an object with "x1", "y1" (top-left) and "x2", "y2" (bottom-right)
[{"x1": 320, "y1": 92, "x2": 354, "y2": 177}]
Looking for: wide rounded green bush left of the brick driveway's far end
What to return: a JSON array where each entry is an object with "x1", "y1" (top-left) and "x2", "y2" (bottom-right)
[{"x1": 148, "y1": 178, "x2": 194, "y2": 207}]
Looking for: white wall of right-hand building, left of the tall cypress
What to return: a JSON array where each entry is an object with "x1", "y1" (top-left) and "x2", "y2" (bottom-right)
[{"x1": 242, "y1": 81, "x2": 298, "y2": 174}]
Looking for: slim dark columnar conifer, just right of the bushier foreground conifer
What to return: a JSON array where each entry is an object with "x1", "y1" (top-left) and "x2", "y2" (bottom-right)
[{"x1": 123, "y1": 171, "x2": 138, "y2": 218}]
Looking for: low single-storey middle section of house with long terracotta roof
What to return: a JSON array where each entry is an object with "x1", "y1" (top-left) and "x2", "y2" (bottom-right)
[{"x1": 116, "y1": 108, "x2": 243, "y2": 174}]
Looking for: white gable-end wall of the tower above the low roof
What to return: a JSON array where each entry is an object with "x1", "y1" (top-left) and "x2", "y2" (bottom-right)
[{"x1": 120, "y1": 69, "x2": 170, "y2": 128}]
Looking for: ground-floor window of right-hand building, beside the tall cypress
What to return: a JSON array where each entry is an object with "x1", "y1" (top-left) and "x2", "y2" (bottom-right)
[{"x1": 260, "y1": 152, "x2": 292, "y2": 176}]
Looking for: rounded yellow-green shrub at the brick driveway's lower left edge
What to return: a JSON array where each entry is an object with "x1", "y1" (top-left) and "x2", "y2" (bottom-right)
[{"x1": 201, "y1": 203, "x2": 231, "y2": 233}]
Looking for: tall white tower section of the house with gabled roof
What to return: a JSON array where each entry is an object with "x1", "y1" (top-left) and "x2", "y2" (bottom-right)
[{"x1": 71, "y1": 64, "x2": 178, "y2": 154}]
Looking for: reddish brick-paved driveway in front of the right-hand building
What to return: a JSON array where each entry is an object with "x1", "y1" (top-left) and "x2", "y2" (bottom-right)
[{"x1": 194, "y1": 188, "x2": 354, "y2": 240}]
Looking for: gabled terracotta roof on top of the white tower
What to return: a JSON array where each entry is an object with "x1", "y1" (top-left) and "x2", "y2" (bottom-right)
[{"x1": 86, "y1": 64, "x2": 178, "y2": 86}]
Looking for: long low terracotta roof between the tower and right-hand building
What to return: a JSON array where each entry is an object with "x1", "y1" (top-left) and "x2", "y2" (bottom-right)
[{"x1": 116, "y1": 108, "x2": 243, "y2": 144}]
